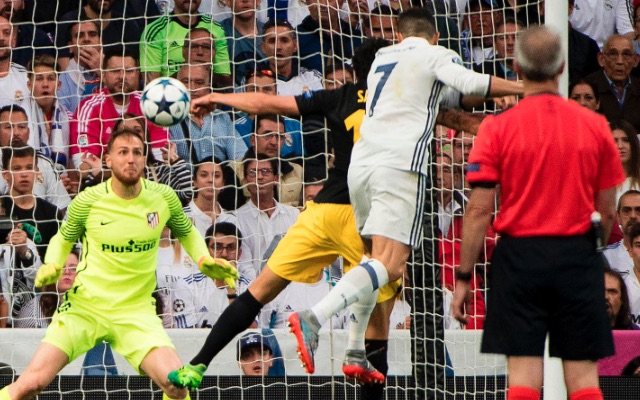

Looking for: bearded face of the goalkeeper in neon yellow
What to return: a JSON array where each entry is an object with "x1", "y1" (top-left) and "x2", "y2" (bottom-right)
[{"x1": 107, "y1": 135, "x2": 146, "y2": 186}]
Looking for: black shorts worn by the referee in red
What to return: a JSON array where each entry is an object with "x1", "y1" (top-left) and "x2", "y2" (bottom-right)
[{"x1": 481, "y1": 235, "x2": 614, "y2": 361}]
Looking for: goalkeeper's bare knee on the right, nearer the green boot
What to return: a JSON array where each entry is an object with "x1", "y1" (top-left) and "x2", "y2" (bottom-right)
[{"x1": 140, "y1": 347, "x2": 190, "y2": 399}]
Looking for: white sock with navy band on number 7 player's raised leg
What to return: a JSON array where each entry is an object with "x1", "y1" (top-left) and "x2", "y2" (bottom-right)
[{"x1": 311, "y1": 258, "x2": 389, "y2": 326}]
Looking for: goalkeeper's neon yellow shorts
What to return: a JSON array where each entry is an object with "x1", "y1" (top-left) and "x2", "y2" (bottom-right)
[{"x1": 42, "y1": 286, "x2": 175, "y2": 374}]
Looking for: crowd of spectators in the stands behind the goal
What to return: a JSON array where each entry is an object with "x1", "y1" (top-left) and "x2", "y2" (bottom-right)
[{"x1": 0, "y1": 0, "x2": 640, "y2": 378}]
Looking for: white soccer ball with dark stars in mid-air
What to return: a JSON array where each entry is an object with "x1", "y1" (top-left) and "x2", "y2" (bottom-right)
[{"x1": 140, "y1": 78, "x2": 191, "y2": 127}]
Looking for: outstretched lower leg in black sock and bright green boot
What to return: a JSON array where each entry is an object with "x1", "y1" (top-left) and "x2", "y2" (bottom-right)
[{"x1": 168, "y1": 265, "x2": 289, "y2": 389}]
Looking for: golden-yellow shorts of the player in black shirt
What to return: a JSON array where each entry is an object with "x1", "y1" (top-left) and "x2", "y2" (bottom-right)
[{"x1": 267, "y1": 201, "x2": 402, "y2": 303}]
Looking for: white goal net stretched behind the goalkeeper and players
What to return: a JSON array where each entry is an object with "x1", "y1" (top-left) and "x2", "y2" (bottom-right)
[{"x1": 0, "y1": 0, "x2": 608, "y2": 399}]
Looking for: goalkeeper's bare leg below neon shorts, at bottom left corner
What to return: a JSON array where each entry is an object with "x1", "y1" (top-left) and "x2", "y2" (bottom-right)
[{"x1": 0, "y1": 343, "x2": 69, "y2": 400}]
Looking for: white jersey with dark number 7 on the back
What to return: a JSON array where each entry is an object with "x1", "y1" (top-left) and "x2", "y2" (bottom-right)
[{"x1": 351, "y1": 37, "x2": 490, "y2": 174}]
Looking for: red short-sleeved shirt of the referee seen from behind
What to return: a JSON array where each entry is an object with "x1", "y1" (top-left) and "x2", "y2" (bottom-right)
[{"x1": 466, "y1": 94, "x2": 624, "y2": 237}]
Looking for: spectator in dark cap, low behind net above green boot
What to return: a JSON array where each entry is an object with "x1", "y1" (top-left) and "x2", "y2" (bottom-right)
[{"x1": 237, "y1": 329, "x2": 284, "y2": 376}]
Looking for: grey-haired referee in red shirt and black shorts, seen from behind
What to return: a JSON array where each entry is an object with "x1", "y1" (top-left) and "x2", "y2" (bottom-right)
[{"x1": 453, "y1": 26, "x2": 625, "y2": 400}]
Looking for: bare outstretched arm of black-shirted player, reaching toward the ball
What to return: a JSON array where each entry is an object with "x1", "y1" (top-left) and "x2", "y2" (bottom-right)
[{"x1": 191, "y1": 93, "x2": 299, "y2": 116}]
